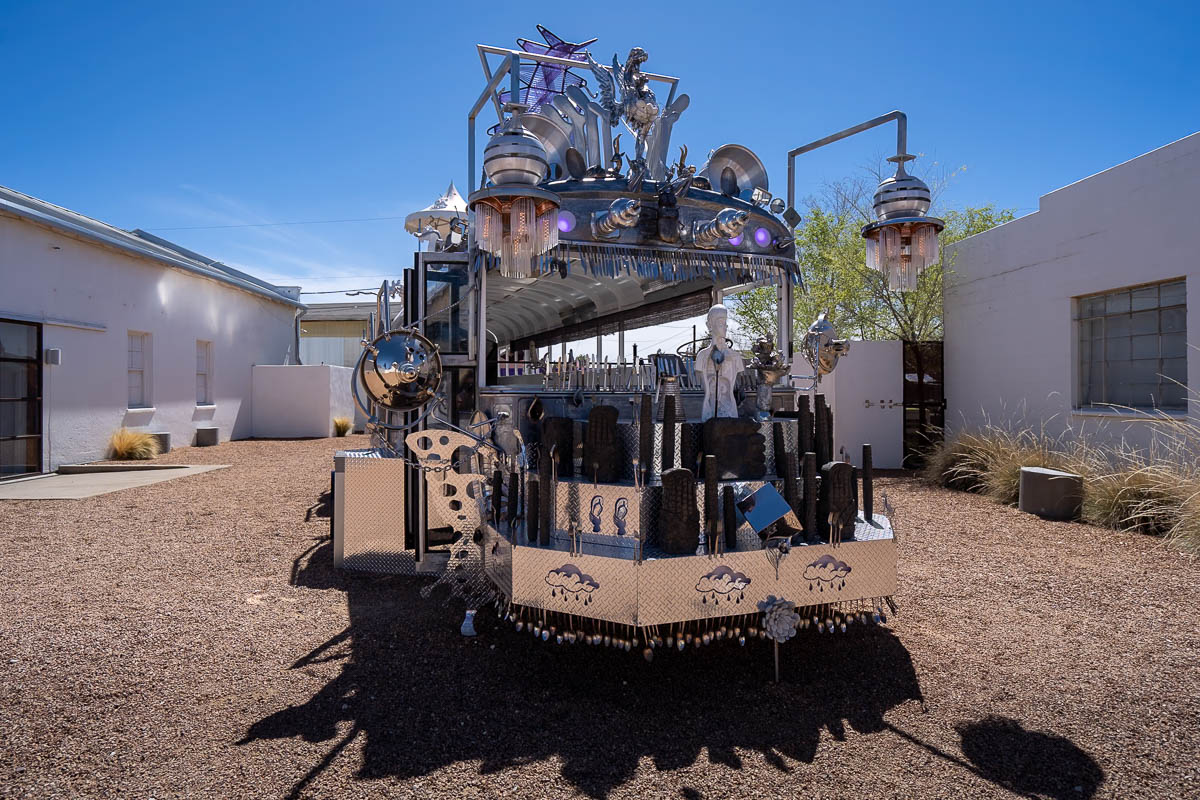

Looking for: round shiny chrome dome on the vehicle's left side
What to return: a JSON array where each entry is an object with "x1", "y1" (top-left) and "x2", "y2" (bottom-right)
[{"x1": 358, "y1": 330, "x2": 442, "y2": 413}]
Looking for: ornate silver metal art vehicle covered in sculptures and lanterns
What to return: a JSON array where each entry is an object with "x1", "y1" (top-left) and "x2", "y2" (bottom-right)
[{"x1": 334, "y1": 28, "x2": 941, "y2": 681}]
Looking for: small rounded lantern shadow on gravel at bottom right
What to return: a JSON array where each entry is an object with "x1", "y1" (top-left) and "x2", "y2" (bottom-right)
[{"x1": 956, "y1": 716, "x2": 1104, "y2": 800}]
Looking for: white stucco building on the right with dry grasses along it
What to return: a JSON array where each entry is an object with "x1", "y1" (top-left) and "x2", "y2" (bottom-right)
[{"x1": 944, "y1": 133, "x2": 1200, "y2": 445}]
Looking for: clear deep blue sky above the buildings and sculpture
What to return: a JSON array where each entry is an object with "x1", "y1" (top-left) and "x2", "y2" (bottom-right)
[{"x1": 0, "y1": 0, "x2": 1200, "y2": 352}]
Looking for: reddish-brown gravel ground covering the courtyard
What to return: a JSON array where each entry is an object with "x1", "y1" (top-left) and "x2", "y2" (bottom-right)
[{"x1": 0, "y1": 437, "x2": 1200, "y2": 800}]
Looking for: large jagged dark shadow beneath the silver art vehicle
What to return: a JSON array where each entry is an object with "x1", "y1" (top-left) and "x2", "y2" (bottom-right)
[{"x1": 246, "y1": 541, "x2": 936, "y2": 798}]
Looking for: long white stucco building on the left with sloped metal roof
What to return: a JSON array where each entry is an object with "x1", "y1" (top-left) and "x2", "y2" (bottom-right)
[{"x1": 0, "y1": 187, "x2": 304, "y2": 477}]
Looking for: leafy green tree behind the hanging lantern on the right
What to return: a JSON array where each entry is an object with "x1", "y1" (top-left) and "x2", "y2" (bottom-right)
[{"x1": 728, "y1": 165, "x2": 1013, "y2": 341}]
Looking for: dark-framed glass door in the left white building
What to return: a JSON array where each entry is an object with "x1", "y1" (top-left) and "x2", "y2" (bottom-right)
[{"x1": 0, "y1": 319, "x2": 42, "y2": 480}]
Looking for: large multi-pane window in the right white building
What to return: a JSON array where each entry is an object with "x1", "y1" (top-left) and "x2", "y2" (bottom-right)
[{"x1": 1075, "y1": 279, "x2": 1188, "y2": 411}]
